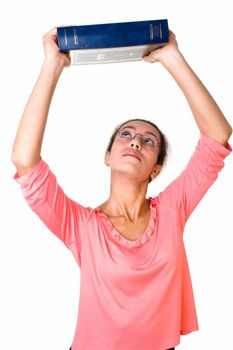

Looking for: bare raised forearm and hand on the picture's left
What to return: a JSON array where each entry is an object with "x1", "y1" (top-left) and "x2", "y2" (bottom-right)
[{"x1": 12, "y1": 28, "x2": 70, "y2": 176}]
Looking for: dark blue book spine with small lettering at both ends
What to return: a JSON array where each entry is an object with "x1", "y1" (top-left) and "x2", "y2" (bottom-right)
[{"x1": 57, "y1": 19, "x2": 169, "y2": 51}]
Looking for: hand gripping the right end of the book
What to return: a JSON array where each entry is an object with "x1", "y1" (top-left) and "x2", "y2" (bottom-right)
[{"x1": 142, "y1": 30, "x2": 179, "y2": 63}]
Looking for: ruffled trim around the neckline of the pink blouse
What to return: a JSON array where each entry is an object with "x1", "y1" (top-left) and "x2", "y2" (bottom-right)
[{"x1": 94, "y1": 197, "x2": 158, "y2": 248}]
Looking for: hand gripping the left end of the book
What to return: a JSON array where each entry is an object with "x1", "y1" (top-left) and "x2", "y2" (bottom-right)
[{"x1": 43, "y1": 27, "x2": 70, "y2": 67}]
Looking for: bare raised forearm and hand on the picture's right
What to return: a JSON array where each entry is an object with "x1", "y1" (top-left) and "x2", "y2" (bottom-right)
[{"x1": 143, "y1": 32, "x2": 232, "y2": 145}]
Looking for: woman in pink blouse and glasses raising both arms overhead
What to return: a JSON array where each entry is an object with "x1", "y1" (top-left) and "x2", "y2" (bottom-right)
[{"x1": 12, "y1": 28, "x2": 232, "y2": 350}]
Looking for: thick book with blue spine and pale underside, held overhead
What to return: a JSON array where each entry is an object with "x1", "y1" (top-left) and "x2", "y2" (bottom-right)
[{"x1": 57, "y1": 19, "x2": 169, "y2": 65}]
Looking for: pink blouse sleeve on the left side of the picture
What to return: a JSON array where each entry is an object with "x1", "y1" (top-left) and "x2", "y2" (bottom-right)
[{"x1": 14, "y1": 159, "x2": 90, "y2": 262}]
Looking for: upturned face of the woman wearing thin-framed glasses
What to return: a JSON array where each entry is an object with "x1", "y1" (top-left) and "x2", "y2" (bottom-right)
[{"x1": 105, "y1": 121, "x2": 161, "y2": 182}]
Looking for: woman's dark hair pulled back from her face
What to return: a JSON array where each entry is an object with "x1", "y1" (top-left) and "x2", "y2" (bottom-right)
[{"x1": 106, "y1": 118, "x2": 168, "y2": 183}]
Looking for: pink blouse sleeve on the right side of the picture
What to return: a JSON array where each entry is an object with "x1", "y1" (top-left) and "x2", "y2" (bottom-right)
[{"x1": 159, "y1": 134, "x2": 232, "y2": 222}]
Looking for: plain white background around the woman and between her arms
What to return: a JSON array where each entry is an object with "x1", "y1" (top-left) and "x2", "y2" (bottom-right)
[{"x1": 0, "y1": 0, "x2": 233, "y2": 350}]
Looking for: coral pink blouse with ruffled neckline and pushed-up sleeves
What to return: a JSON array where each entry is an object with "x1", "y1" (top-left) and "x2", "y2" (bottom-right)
[{"x1": 14, "y1": 135, "x2": 232, "y2": 350}]
